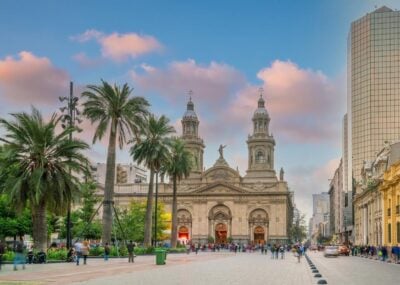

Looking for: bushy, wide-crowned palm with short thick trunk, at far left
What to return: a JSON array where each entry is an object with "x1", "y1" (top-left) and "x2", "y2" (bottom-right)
[{"x1": 0, "y1": 108, "x2": 89, "y2": 250}]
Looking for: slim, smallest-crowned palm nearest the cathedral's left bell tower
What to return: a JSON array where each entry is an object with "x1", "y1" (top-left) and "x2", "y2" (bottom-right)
[{"x1": 161, "y1": 138, "x2": 192, "y2": 248}]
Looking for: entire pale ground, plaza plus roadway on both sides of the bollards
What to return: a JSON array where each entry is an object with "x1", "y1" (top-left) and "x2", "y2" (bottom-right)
[{"x1": 0, "y1": 252, "x2": 400, "y2": 285}]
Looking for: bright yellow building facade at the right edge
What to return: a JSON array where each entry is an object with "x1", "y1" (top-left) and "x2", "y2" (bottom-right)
[{"x1": 380, "y1": 160, "x2": 400, "y2": 246}]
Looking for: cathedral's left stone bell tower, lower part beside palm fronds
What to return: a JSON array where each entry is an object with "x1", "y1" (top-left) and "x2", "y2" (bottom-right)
[{"x1": 181, "y1": 90, "x2": 205, "y2": 178}]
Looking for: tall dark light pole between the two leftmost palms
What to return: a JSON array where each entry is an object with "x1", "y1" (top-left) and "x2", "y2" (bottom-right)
[{"x1": 59, "y1": 81, "x2": 82, "y2": 249}]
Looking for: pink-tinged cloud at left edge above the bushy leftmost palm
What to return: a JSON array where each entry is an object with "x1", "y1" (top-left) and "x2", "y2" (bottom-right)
[{"x1": 0, "y1": 51, "x2": 69, "y2": 106}]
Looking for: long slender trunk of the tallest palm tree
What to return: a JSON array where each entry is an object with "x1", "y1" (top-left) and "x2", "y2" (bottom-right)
[{"x1": 101, "y1": 120, "x2": 117, "y2": 244}]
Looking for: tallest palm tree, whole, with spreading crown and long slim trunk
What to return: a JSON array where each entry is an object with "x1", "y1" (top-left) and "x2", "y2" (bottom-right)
[{"x1": 82, "y1": 80, "x2": 149, "y2": 243}]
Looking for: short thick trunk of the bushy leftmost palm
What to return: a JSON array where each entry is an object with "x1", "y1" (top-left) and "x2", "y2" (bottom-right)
[{"x1": 32, "y1": 199, "x2": 47, "y2": 252}]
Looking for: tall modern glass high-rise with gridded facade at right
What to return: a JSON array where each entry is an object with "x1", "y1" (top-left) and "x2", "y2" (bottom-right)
[{"x1": 345, "y1": 6, "x2": 400, "y2": 186}]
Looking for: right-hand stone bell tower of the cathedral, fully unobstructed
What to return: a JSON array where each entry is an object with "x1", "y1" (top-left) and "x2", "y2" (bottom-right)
[{"x1": 245, "y1": 88, "x2": 277, "y2": 182}]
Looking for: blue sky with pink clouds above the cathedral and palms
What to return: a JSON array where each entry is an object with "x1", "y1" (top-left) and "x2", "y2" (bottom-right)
[{"x1": 0, "y1": 0, "x2": 400, "y2": 218}]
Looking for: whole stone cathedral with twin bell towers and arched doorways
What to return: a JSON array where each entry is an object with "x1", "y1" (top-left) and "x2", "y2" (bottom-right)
[{"x1": 106, "y1": 91, "x2": 293, "y2": 244}]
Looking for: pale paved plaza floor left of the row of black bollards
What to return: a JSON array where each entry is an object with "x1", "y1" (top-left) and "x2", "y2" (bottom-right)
[{"x1": 0, "y1": 252, "x2": 315, "y2": 285}]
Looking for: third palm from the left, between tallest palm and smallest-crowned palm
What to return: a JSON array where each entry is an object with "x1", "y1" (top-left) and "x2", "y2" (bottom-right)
[{"x1": 130, "y1": 115, "x2": 175, "y2": 246}]
